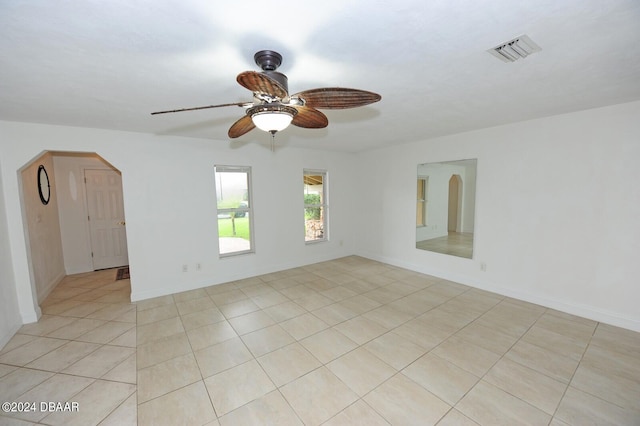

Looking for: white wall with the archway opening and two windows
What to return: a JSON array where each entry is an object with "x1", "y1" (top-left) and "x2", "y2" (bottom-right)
[{"x1": 0, "y1": 122, "x2": 356, "y2": 322}]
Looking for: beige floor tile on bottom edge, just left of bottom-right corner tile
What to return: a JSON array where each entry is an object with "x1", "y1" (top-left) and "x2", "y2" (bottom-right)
[{"x1": 456, "y1": 381, "x2": 551, "y2": 426}]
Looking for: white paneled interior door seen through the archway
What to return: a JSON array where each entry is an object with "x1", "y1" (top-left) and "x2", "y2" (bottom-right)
[{"x1": 84, "y1": 170, "x2": 129, "y2": 270}]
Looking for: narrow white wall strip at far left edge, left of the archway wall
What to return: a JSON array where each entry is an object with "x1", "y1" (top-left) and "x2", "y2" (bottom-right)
[{"x1": 0, "y1": 160, "x2": 22, "y2": 348}]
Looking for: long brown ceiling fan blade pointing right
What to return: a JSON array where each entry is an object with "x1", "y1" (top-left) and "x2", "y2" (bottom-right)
[{"x1": 293, "y1": 87, "x2": 382, "y2": 109}]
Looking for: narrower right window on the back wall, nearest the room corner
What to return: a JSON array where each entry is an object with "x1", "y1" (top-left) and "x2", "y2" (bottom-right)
[{"x1": 304, "y1": 170, "x2": 328, "y2": 242}]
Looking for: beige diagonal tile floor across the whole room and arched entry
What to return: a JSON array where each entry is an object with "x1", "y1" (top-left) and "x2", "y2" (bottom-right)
[{"x1": 0, "y1": 256, "x2": 640, "y2": 426}]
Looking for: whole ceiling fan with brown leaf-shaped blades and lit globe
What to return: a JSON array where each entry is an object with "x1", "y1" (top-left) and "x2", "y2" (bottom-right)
[{"x1": 151, "y1": 50, "x2": 381, "y2": 138}]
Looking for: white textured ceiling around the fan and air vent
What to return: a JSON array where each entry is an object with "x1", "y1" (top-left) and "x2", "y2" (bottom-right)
[{"x1": 0, "y1": 0, "x2": 640, "y2": 152}]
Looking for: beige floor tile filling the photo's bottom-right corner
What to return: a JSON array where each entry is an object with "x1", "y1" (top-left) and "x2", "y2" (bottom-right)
[{"x1": 556, "y1": 387, "x2": 640, "y2": 426}]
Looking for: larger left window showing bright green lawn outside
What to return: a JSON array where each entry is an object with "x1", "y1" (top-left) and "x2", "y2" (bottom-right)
[{"x1": 215, "y1": 166, "x2": 254, "y2": 257}]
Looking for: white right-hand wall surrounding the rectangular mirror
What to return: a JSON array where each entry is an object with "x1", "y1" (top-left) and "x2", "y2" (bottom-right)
[{"x1": 355, "y1": 102, "x2": 640, "y2": 331}]
